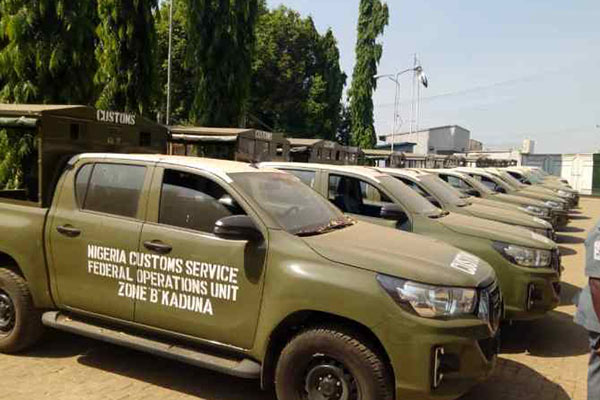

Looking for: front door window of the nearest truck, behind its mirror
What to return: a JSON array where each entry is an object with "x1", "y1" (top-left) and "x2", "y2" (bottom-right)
[{"x1": 158, "y1": 170, "x2": 245, "y2": 233}]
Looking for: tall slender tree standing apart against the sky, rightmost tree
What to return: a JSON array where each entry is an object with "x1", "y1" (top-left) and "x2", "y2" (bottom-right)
[{"x1": 348, "y1": 0, "x2": 389, "y2": 149}]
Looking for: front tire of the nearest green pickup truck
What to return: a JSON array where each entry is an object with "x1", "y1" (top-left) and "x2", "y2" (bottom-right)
[{"x1": 275, "y1": 327, "x2": 394, "y2": 400}]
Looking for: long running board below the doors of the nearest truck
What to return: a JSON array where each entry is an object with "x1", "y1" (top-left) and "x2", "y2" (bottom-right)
[{"x1": 42, "y1": 311, "x2": 261, "y2": 379}]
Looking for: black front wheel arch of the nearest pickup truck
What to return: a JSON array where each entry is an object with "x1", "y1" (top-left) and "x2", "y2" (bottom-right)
[{"x1": 261, "y1": 310, "x2": 395, "y2": 389}]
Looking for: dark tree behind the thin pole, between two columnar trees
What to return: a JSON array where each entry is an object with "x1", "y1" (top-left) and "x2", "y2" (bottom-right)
[{"x1": 156, "y1": 0, "x2": 196, "y2": 125}]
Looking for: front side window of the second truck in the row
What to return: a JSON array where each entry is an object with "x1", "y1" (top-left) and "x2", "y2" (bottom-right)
[{"x1": 328, "y1": 175, "x2": 392, "y2": 218}]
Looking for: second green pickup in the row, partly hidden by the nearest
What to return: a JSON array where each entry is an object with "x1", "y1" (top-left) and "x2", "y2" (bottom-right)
[{"x1": 260, "y1": 162, "x2": 561, "y2": 320}]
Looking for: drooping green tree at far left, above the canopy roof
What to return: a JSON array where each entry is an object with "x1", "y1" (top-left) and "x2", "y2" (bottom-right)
[{"x1": 0, "y1": 0, "x2": 97, "y2": 104}]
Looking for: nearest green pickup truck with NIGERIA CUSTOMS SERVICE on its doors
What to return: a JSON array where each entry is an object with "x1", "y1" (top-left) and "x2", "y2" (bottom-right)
[{"x1": 0, "y1": 106, "x2": 503, "y2": 400}]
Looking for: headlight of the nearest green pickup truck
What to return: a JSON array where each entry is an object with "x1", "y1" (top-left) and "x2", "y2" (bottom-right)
[{"x1": 377, "y1": 275, "x2": 477, "y2": 318}]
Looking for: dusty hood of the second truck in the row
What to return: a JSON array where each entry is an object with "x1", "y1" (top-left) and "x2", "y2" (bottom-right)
[{"x1": 438, "y1": 213, "x2": 556, "y2": 250}]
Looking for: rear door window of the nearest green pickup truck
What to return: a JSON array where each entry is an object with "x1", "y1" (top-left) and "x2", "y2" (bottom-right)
[{"x1": 81, "y1": 164, "x2": 146, "y2": 218}]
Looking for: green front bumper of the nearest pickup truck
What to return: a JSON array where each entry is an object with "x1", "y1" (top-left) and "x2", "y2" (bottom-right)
[{"x1": 374, "y1": 317, "x2": 498, "y2": 400}]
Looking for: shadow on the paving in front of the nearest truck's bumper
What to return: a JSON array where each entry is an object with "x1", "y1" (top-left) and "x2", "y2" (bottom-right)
[{"x1": 460, "y1": 358, "x2": 571, "y2": 400}]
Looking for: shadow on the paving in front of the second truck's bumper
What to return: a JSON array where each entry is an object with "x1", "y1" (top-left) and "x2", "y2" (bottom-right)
[{"x1": 500, "y1": 310, "x2": 588, "y2": 358}]
